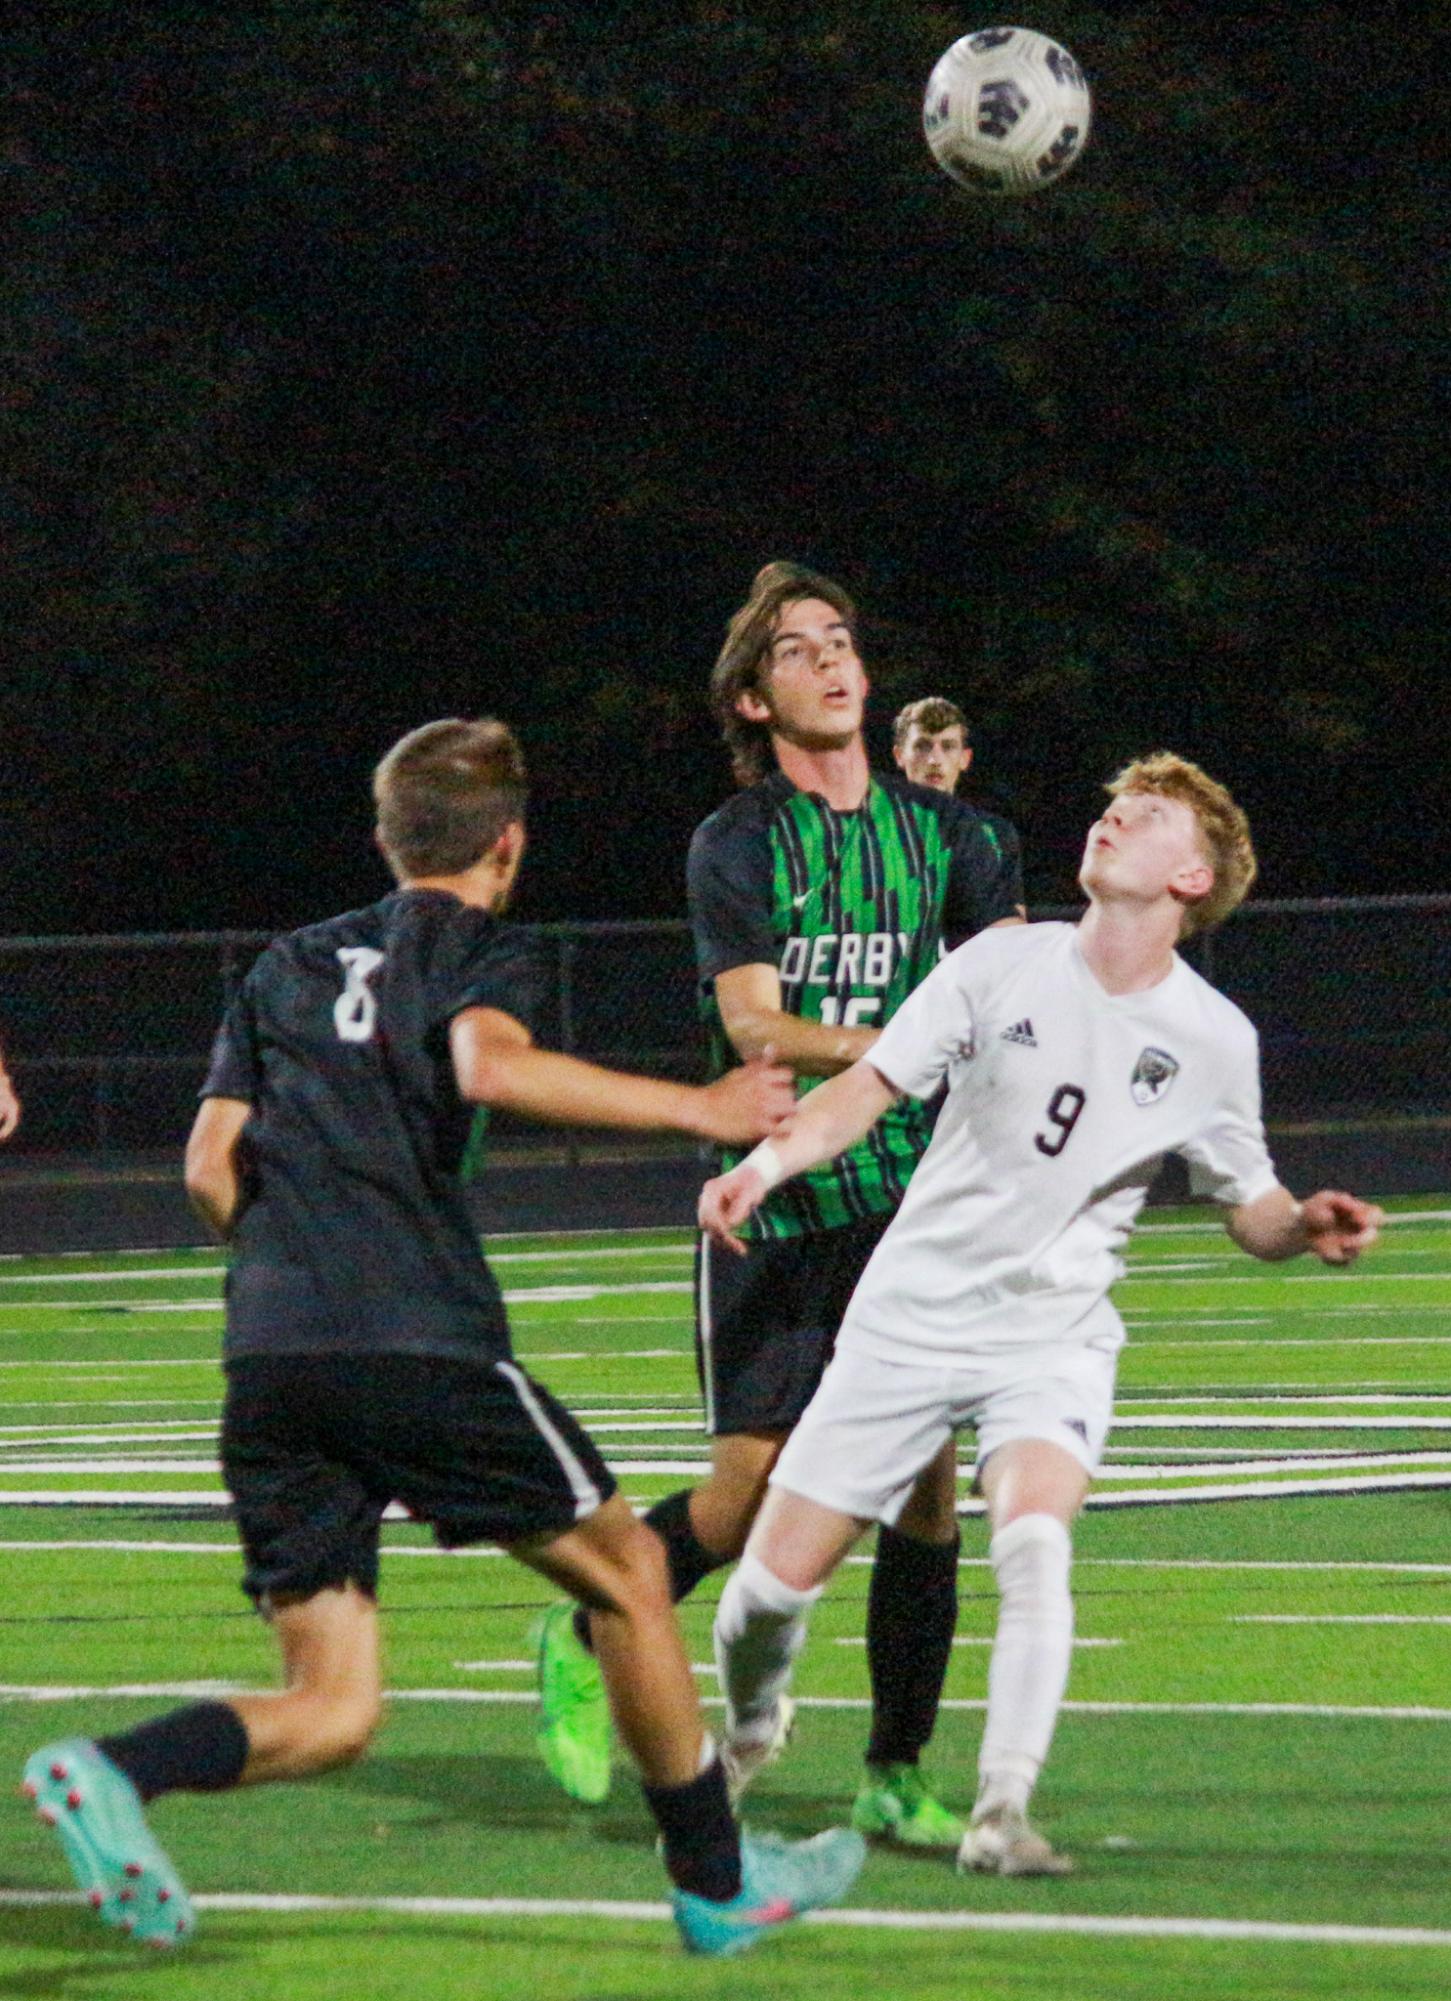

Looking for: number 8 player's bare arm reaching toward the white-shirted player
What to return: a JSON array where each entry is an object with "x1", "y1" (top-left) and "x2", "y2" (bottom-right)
[{"x1": 448, "y1": 1007, "x2": 793, "y2": 1145}]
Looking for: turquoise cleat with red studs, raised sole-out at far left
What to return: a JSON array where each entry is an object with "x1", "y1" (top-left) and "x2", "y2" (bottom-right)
[{"x1": 22, "y1": 1737, "x2": 196, "y2": 1947}]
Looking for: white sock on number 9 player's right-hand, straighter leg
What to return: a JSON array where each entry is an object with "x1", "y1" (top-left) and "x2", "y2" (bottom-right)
[{"x1": 977, "y1": 1515, "x2": 1073, "y2": 1809}]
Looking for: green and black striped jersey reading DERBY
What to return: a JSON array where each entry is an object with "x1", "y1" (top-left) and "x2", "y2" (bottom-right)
[{"x1": 688, "y1": 772, "x2": 1023, "y2": 1237}]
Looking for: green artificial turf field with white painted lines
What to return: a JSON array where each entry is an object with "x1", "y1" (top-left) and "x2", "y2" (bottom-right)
[{"x1": 0, "y1": 1201, "x2": 1451, "y2": 2001}]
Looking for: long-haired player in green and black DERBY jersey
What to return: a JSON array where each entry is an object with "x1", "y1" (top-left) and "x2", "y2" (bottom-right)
[{"x1": 540, "y1": 562, "x2": 1023, "y2": 1847}]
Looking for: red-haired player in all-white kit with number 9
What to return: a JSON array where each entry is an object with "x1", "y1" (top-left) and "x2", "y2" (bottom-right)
[{"x1": 700, "y1": 752, "x2": 1381, "y2": 1875}]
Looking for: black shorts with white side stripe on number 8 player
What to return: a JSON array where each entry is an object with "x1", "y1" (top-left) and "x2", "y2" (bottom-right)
[{"x1": 222, "y1": 1355, "x2": 614, "y2": 1601}]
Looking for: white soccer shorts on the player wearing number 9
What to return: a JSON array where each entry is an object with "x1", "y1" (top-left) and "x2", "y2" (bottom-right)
[{"x1": 771, "y1": 1333, "x2": 1121, "y2": 1527}]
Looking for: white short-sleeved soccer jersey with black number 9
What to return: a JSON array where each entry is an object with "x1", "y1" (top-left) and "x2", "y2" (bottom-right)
[{"x1": 839, "y1": 924, "x2": 1275, "y2": 1365}]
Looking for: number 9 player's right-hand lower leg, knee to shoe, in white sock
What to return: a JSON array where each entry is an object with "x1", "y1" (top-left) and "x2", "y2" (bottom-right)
[{"x1": 959, "y1": 1439, "x2": 1089, "y2": 1875}]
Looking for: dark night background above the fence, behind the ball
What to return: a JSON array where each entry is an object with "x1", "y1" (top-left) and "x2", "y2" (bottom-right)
[{"x1": 0, "y1": 0, "x2": 1451, "y2": 932}]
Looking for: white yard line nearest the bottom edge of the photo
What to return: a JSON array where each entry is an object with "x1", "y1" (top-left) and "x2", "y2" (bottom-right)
[{"x1": 0, "y1": 1889, "x2": 1451, "y2": 1951}]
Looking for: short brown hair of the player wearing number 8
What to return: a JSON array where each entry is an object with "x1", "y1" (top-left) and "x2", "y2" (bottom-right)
[{"x1": 372, "y1": 716, "x2": 528, "y2": 880}]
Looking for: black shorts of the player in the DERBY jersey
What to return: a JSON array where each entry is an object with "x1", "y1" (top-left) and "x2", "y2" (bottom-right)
[{"x1": 694, "y1": 1215, "x2": 891, "y2": 1437}]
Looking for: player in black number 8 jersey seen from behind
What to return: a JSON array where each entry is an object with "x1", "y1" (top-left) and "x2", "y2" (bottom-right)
[{"x1": 26, "y1": 720, "x2": 863, "y2": 1953}]
